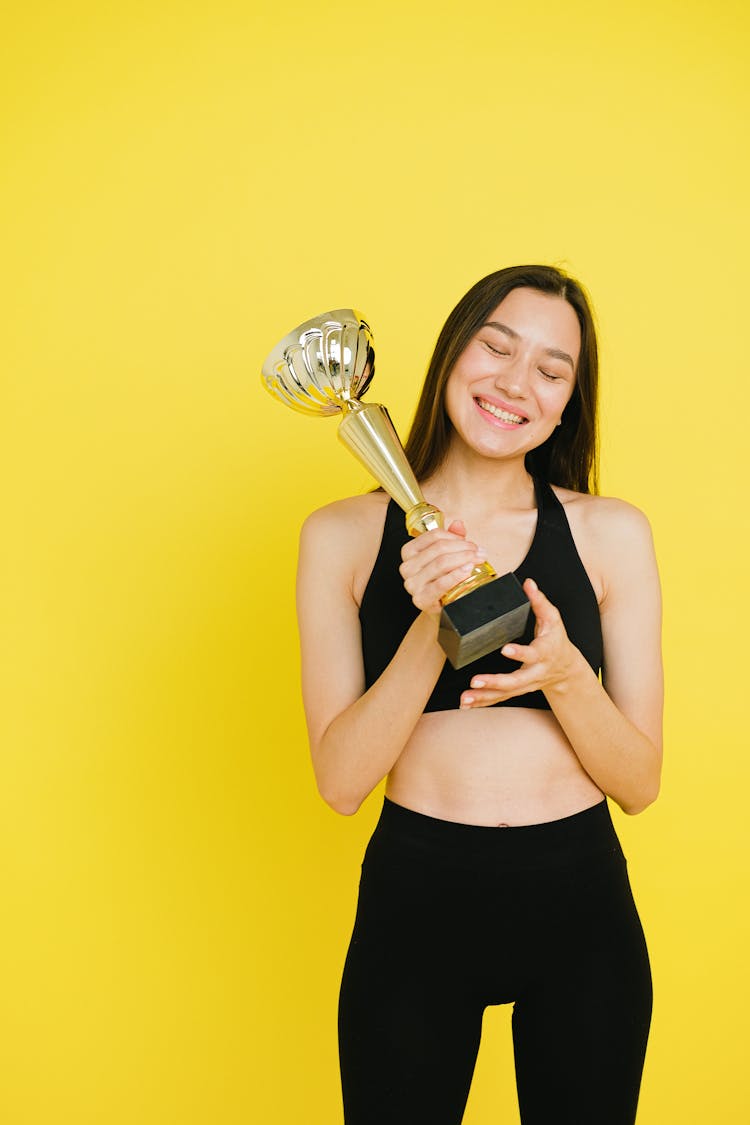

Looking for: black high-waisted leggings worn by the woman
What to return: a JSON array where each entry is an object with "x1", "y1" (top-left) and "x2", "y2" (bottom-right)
[{"x1": 338, "y1": 799, "x2": 651, "y2": 1125}]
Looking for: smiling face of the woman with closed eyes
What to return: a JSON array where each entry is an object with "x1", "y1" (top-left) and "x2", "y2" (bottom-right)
[{"x1": 445, "y1": 289, "x2": 580, "y2": 458}]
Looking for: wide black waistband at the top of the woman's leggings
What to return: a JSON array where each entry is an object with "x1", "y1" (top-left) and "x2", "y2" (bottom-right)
[{"x1": 371, "y1": 798, "x2": 622, "y2": 871}]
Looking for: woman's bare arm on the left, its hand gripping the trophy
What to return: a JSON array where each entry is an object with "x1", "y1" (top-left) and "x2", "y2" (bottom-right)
[{"x1": 297, "y1": 497, "x2": 476, "y2": 816}]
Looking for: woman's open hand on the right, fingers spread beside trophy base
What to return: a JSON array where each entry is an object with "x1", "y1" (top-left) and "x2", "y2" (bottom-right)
[{"x1": 461, "y1": 578, "x2": 580, "y2": 710}]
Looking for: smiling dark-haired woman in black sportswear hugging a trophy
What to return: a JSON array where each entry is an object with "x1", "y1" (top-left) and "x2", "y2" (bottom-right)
[{"x1": 298, "y1": 266, "x2": 662, "y2": 1125}]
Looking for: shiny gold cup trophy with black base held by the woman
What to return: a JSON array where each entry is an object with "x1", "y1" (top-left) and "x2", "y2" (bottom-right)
[{"x1": 262, "y1": 308, "x2": 530, "y2": 668}]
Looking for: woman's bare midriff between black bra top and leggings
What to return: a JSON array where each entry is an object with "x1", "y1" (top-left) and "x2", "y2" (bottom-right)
[{"x1": 386, "y1": 707, "x2": 604, "y2": 826}]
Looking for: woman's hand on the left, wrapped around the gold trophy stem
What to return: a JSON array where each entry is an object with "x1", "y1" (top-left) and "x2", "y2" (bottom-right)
[{"x1": 399, "y1": 520, "x2": 487, "y2": 614}]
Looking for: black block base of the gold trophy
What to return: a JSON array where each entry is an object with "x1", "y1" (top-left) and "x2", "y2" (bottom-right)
[{"x1": 437, "y1": 574, "x2": 531, "y2": 668}]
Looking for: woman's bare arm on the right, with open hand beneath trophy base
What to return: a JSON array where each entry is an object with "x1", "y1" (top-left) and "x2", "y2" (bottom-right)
[{"x1": 461, "y1": 501, "x2": 663, "y2": 813}]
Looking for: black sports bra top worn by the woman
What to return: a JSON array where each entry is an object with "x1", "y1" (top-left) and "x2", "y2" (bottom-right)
[{"x1": 360, "y1": 479, "x2": 602, "y2": 711}]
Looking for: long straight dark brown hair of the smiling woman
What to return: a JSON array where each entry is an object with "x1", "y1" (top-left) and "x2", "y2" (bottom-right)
[{"x1": 405, "y1": 266, "x2": 599, "y2": 493}]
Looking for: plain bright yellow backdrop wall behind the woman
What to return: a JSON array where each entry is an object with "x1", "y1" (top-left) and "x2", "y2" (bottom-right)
[{"x1": 0, "y1": 0, "x2": 750, "y2": 1125}]
